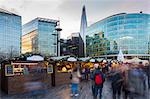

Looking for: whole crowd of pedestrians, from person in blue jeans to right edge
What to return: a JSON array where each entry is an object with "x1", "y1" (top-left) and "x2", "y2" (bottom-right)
[{"x1": 71, "y1": 60, "x2": 150, "y2": 99}]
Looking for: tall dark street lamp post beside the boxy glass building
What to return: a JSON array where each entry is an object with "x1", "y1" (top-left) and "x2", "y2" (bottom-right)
[{"x1": 52, "y1": 21, "x2": 62, "y2": 56}]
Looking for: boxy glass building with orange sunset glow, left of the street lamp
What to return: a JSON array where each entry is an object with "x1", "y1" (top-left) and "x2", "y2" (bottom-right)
[{"x1": 22, "y1": 18, "x2": 58, "y2": 56}]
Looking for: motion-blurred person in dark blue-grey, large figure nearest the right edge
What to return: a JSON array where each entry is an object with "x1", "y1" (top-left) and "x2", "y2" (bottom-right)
[{"x1": 124, "y1": 64, "x2": 145, "y2": 99}]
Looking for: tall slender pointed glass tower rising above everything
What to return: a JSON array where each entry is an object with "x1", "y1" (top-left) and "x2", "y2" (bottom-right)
[{"x1": 80, "y1": 5, "x2": 87, "y2": 54}]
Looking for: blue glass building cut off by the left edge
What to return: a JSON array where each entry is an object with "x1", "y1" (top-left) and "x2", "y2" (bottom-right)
[{"x1": 0, "y1": 9, "x2": 22, "y2": 58}]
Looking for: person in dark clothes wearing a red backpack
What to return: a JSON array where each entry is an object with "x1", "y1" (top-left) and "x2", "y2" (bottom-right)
[{"x1": 91, "y1": 64, "x2": 105, "y2": 99}]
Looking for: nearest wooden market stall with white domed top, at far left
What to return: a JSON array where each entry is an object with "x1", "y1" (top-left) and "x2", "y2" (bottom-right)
[{"x1": 1, "y1": 55, "x2": 53, "y2": 94}]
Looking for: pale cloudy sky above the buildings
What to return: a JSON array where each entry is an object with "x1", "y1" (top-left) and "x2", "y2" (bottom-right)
[{"x1": 0, "y1": 0, "x2": 150, "y2": 38}]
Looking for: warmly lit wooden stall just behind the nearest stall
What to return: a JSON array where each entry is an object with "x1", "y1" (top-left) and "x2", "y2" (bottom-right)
[{"x1": 52, "y1": 56, "x2": 77, "y2": 86}]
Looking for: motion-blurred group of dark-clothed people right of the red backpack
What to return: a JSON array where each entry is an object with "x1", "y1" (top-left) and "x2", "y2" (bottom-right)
[{"x1": 107, "y1": 62, "x2": 150, "y2": 99}]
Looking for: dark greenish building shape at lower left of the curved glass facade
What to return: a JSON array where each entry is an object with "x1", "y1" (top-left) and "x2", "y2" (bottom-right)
[{"x1": 86, "y1": 32, "x2": 110, "y2": 57}]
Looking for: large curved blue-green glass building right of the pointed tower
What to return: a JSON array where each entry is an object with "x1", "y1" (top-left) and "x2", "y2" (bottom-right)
[{"x1": 86, "y1": 13, "x2": 150, "y2": 56}]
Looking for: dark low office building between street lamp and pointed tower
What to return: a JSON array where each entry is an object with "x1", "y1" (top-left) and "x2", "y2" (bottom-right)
[{"x1": 60, "y1": 33, "x2": 84, "y2": 57}]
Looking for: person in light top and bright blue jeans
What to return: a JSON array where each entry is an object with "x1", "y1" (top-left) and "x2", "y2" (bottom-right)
[{"x1": 71, "y1": 67, "x2": 81, "y2": 96}]
